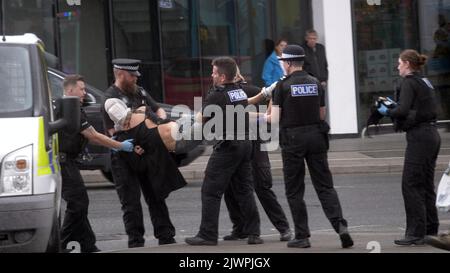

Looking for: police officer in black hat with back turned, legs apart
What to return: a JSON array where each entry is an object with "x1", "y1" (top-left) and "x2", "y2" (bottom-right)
[{"x1": 269, "y1": 45, "x2": 353, "y2": 248}]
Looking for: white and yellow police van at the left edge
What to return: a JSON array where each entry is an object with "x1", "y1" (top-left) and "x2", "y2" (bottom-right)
[{"x1": 0, "y1": 34, "x2": 80, "y2": 253}]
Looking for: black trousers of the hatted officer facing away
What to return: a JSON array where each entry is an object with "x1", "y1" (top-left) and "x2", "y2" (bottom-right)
[{"x1": 280, "y1": 126, "x2": 347, "y2": 239}]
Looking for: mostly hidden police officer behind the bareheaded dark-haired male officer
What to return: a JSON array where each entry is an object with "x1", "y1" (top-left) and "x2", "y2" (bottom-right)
[{"x1": 223, "y1": 68, "x2": 292, "y2": 241}]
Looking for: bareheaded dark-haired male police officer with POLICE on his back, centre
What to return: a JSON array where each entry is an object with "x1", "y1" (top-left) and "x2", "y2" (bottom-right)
[{"x1": 186, "y1": 57, "x2": 263, "y2": 245}]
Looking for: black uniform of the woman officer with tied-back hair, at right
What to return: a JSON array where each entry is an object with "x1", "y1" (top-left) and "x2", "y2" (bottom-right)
[{"x1": 389, "y1": 74, "x2": 441, "y2": 237}]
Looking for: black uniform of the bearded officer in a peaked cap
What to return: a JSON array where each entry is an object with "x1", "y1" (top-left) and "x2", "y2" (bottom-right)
[{"x1": 102, "y1": 85, "x2": 175, "y2": 247}]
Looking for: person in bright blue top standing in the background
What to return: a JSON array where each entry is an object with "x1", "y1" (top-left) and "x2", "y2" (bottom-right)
[{"x1": 262, "y1": 39, "x2": 288, "y2": 86}]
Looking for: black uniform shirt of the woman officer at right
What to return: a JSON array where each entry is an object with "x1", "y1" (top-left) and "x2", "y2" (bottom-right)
[{"x1": 389, "y1": 73, "x2": 437, "y2": 127}]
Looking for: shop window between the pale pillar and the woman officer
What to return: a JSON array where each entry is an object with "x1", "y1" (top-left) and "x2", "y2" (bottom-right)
[{"x1": 352, "y1": 0, "x2": 419, "y2": 127}]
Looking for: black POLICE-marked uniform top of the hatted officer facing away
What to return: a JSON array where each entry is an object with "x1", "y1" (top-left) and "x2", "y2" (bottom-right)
[{"x1": 273, "y1": 71, "x2": 325, "y2": 128}]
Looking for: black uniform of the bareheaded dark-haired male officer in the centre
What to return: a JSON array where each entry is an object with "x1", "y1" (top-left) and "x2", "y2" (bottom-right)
[{"x1": 197, "y1": 84, "x2": 260, "y2": 241}]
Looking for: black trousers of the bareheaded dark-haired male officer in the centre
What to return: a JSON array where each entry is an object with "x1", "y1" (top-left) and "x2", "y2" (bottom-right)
[{"x1": 197, "y1": 141, "x2": 260, "y2": 241}]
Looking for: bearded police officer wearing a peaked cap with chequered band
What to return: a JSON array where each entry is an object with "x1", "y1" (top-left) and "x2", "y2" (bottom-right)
[{"x1": 102, "y1": 59, "x2": 176, "y2": 248}]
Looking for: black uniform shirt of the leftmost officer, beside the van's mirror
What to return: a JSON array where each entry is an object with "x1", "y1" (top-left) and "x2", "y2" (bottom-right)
[{"x1": 59, "y1": 108, "x2": 91, "y2": 158}]
